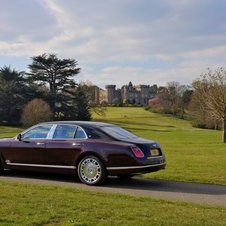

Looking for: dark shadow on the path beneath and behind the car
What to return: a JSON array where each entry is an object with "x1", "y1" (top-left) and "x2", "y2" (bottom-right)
[{"x1": 1, "y1": 171, "x2": 226, "y2": 195}]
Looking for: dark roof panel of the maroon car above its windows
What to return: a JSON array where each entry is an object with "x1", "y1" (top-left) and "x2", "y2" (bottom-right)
[{"x1": 40, "y1": 121, "x2": 115, "y2": 127}]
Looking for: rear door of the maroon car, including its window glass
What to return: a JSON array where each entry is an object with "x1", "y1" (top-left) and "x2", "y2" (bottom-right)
[{"x1": 46, "y1": 124, "x2": 87, "y2": 169}]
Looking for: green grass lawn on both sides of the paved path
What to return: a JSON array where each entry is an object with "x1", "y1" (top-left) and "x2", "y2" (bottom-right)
[{"x1": 0, "y1": 108, "x2": 226, "y2": 226}]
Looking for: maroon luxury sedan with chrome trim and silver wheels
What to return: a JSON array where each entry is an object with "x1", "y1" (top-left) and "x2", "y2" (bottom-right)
[{"x1": 0, "y1": 121, "x2": 166, "y2": 185}]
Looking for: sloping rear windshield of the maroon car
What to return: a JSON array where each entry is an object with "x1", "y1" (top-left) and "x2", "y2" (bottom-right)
[{"x1": 101, "y1": 126, "x2": 137, "y2": 139}]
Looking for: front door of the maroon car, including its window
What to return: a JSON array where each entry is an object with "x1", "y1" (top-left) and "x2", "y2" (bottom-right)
[{"x1": 3, "y1": 124, "x2": 52, "y2": 168}]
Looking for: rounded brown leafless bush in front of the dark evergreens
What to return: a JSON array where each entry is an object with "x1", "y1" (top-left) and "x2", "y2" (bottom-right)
[{"x1": 21, "y1": 98, "x2": 53, "y2": 127}]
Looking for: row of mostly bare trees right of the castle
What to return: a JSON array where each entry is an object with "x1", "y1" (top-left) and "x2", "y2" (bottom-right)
[{"x1": 148, "y1": 68, "x2": 226, "y2": 142}]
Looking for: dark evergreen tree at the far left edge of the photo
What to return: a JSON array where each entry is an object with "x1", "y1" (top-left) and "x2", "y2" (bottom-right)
[{"x1": 0, "y1": 66, "x2": 30, "y2": 124}]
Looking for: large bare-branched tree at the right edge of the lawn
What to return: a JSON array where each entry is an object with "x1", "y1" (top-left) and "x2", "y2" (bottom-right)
[{"x1": 193, "y1": 68, "x2": 226, "y2": 143}]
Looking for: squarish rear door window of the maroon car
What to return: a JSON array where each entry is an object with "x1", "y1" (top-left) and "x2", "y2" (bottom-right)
[{"x1": 53, "y1": 125, "x2": 77, "y2": 139}]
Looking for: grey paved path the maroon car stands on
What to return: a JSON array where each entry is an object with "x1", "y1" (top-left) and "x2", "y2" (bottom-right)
[{"x1": 0, "y1": 172, "x2": 226, "y2": 206}]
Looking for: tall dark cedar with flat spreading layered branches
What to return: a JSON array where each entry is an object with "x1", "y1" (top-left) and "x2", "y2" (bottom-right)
[{"x1": 27, "y1": 54, "x2": 80, "y2": 116}]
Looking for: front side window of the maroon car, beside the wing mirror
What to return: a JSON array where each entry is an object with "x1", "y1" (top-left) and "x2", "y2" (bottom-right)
[{"x1": 22, "y1": 125, "x2": 52, "y2": 139}]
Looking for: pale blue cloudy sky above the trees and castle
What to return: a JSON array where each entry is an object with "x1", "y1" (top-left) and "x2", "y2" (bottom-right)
[{"x1": 0, "y1": 0, "x2": 226, "y2": 88}]
